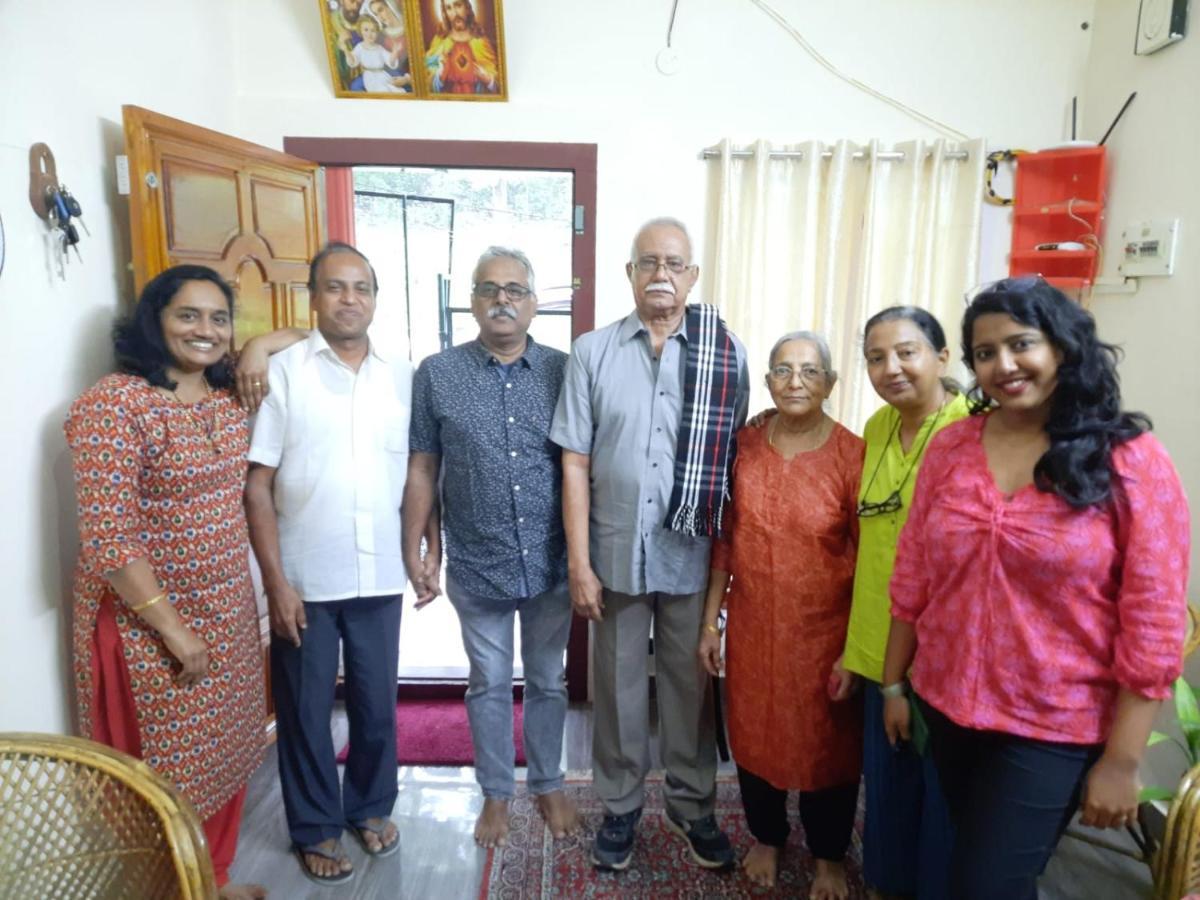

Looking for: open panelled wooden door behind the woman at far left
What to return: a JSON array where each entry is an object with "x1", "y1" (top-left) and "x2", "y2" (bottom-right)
[{"x1": 122, "y1": 106, "x2": 324, "y2": 346}]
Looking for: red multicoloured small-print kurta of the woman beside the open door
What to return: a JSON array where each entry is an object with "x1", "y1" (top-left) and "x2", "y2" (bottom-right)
[{"x1": 65, "y1": 374, "x2": 265, "y2": 818}]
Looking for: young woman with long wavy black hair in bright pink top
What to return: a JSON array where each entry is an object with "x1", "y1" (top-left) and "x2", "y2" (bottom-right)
[{"x1": 882, "y1": 278, "x2": 1189, "y2": 900}]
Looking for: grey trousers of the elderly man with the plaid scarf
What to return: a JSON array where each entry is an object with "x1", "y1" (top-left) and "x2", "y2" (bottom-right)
[{"x1": 592, "y1": 589, "x2": 716, "y2": 821}]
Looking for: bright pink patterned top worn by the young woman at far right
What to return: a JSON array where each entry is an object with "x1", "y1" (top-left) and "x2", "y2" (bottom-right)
[{"x1": 890, "y1": 415, "x2": 1190, "y2": 744}]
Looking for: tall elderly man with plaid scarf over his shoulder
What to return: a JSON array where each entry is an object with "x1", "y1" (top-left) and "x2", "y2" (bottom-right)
[{"x1": 551, "y1": 218, "x2": 750, "y2": 870}]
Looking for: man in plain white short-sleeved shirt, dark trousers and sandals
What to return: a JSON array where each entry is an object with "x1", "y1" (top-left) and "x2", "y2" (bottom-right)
[{"x1": 246, "y1": 244, "x2": 422, "y2": 884}]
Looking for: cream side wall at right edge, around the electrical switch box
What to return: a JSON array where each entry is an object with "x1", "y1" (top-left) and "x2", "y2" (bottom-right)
[{"x1": 1081, "y1": 0, "x2": 1200, "y2": 785}]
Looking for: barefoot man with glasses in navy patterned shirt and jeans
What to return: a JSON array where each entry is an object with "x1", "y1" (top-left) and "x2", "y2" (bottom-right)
[{"x1": 403, "y1": 247, "x2": 578, "y2": 847}]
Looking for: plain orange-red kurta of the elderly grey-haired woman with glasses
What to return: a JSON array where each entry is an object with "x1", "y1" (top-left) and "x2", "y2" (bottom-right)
[{"x1": 712, "y1": 425, "x2": 864, "y2": 791}]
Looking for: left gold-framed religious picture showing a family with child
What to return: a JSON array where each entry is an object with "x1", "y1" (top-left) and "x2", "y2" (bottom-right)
[{"x1": 317, "y1": 0, "x2": 420, "y2": 100}]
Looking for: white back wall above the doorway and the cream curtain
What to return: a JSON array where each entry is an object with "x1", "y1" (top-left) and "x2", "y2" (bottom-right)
[{"x1": 231, "y1": 0, "x2": 1092, "y2": 324}]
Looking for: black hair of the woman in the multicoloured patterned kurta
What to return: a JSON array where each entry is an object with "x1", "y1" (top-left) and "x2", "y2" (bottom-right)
[{"x1": 113, "y1": 265, "x2": 233, "y2": 390}]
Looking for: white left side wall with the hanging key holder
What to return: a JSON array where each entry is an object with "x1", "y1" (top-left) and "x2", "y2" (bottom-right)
[{"x1": 0, "y1": 0, "x2": 234, "y2": 732}]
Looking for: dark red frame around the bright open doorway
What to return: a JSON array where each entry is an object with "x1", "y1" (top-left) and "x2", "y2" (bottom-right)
[{"x1": 283, "y1": 137, "x2": 598, "y2": 702}]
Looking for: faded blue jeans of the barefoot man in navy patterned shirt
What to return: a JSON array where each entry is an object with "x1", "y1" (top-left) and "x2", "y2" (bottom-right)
[{"x1": 446, "y1": 575, "x2": 571, "y2": 799}]
